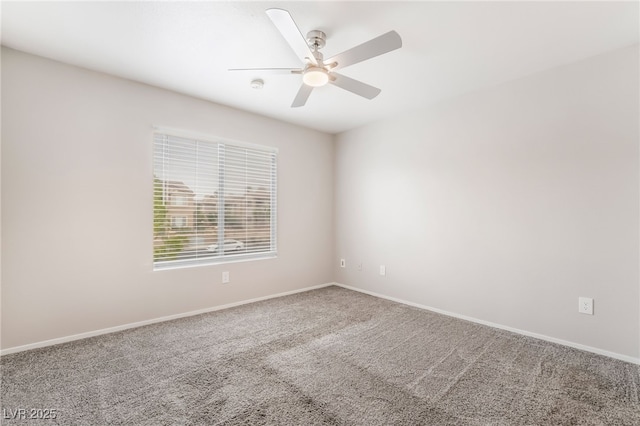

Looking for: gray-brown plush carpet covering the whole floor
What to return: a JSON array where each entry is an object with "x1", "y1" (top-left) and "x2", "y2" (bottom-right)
[{"x1": 0, "y1": 287, "x2": 640, "y2": 425}]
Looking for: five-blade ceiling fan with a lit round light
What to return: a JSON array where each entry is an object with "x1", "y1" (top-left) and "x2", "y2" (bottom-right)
[{"x1": 229, "y1": 9, "x2": 402, "y2": 107}]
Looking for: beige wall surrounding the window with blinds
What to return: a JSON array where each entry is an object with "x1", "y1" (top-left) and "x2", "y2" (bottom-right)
[{"x1": 2, "y1": 48, "x2": 334, "y2": 349}]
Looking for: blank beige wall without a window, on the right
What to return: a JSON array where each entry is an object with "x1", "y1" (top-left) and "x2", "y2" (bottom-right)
[{"x1": 334, "y1": 45, "x2": 640, "y2": 359}]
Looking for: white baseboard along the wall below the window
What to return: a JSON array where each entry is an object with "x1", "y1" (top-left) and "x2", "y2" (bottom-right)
[{"x1": 0, "y1": 283, "x2": 336, "y2": 356}]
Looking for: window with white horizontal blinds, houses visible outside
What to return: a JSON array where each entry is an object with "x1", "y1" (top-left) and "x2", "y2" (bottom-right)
[{"x1": 153, "y1": 132, "x2": 277, "y2": 269}]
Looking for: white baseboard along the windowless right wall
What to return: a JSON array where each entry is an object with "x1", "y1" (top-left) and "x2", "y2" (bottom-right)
[{"x1": 334, "y1": 283, "x2": 640, "y2": 365}]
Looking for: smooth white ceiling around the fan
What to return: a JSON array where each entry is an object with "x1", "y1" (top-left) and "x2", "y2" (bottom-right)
[{"x1": 1, "y1": 1, "x2": 639, "y2": 133}]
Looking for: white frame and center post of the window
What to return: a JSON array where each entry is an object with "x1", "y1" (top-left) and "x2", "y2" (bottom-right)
[{"x1": 151, "y1": 126, "x2": 279, "y2": 271}]
